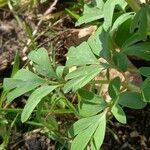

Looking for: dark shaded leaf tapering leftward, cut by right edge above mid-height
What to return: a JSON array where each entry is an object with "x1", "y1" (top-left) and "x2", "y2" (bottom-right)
[{"x1": 122, "y1": 42, "x2": 150, "y2": 61}]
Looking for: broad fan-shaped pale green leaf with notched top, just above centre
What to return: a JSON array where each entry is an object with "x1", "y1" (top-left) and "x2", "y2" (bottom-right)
[{"x1": 66, "y1": 42, "x2": 99, "y2": 67}]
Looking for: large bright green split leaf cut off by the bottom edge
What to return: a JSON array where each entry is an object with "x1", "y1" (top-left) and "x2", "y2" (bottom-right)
[{"x1": 71, "y1": 112, "x2": 106, "y2": 150}]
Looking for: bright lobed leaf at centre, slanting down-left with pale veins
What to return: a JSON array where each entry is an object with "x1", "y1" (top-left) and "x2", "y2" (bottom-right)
[{"x1": 64, "y1": 65, "x2": 103, "y2": 93}]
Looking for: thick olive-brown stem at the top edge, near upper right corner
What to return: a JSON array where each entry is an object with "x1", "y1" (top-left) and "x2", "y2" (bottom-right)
[{"x1": 125, "y1": 0, "x2": 140, "y2": 12}]
